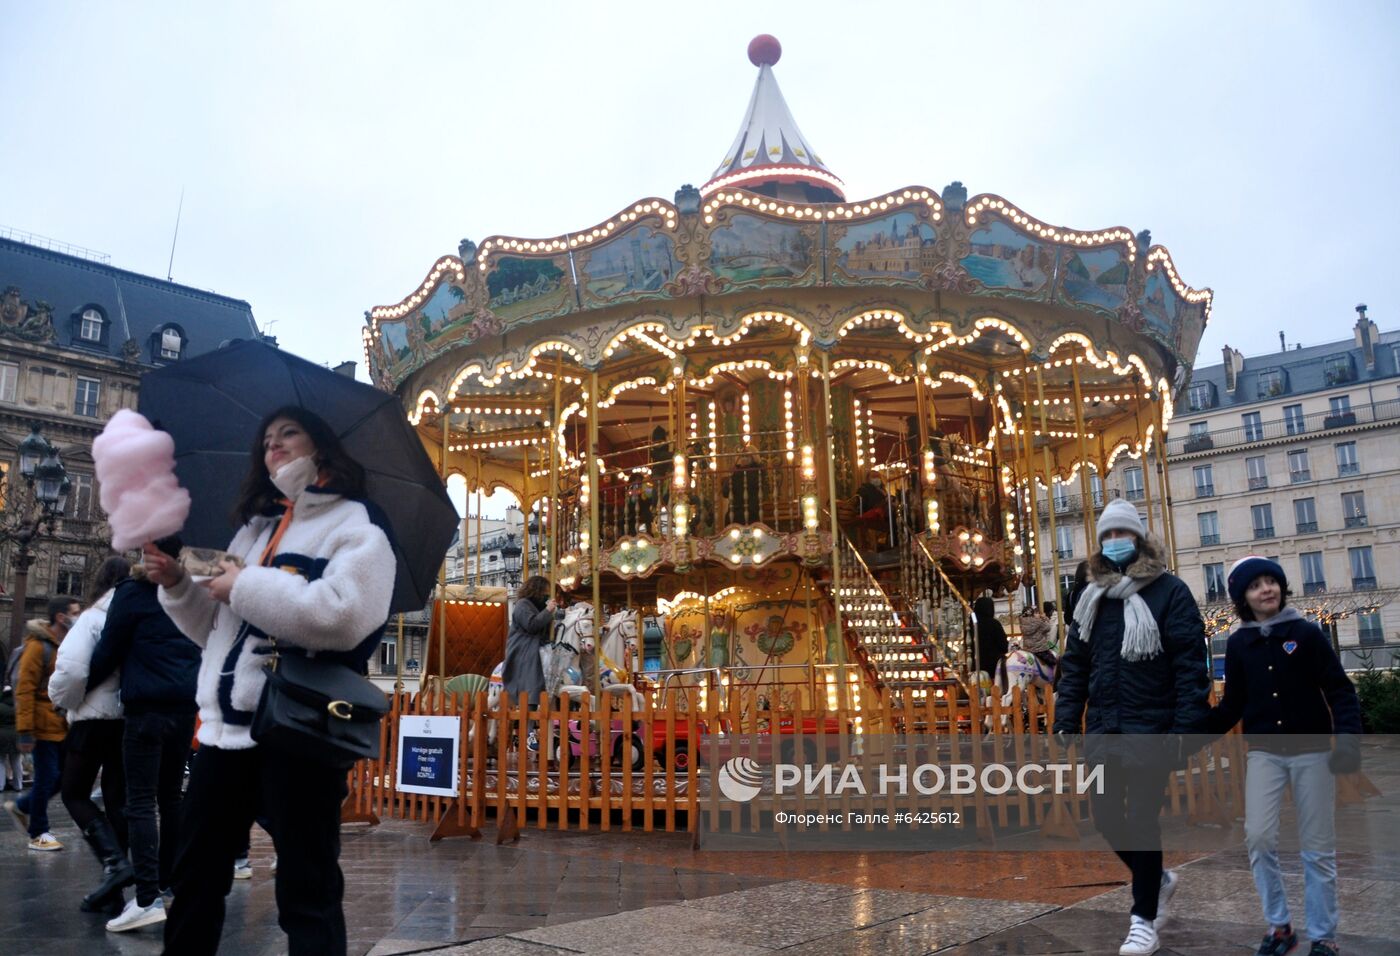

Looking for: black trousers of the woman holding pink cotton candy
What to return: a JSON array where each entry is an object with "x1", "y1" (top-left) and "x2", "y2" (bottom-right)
[{"x1": 165, "y1": 746, "x2": 346, "y2": 956}]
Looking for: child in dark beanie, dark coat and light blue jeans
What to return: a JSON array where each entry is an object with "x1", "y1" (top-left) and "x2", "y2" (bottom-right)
[{"x1": 1208, "y1": 556, "x2": 1361, "y2": 956}]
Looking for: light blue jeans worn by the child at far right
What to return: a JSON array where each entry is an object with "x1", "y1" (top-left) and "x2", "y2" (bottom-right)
[{"x1": 1245, "y1": 750, "x2": 1337, "y2": 941}]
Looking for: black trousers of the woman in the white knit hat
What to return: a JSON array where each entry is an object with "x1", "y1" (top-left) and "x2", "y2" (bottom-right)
[{"x1": 1089, "y1": 760, "x2": 1170, "y2": 920}]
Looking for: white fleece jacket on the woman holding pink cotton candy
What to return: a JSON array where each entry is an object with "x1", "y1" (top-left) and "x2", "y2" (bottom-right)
[{"x1": 160, "y1": 473, "x2": 395, "y2": 750}]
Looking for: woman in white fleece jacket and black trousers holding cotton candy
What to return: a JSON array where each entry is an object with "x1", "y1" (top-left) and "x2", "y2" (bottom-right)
[{"x1": 146, "y1": 407, "x2": 395, "y2": 956}]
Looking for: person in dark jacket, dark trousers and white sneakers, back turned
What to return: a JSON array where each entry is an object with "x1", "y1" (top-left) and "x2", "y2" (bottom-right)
[{"x1": 88, "y1": 537, "x2": 199, "y2": 932}]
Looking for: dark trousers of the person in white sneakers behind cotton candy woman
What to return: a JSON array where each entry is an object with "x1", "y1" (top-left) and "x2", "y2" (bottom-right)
[{"x1": 122, "y1": 712, "x2": 195, "y2": 906}]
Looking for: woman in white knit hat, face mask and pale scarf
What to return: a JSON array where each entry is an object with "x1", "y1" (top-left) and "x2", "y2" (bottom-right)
[{"x1": 1054, "y1": 500, "x2": 1210, "y2": 956}]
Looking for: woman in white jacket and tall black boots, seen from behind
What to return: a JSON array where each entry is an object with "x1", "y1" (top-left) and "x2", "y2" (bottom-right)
[{"x1": 49, "y1": 556, "x2": 134, "y2": 915}]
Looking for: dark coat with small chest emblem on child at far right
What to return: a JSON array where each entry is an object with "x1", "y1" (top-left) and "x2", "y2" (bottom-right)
[{"x1": 1210, "y1": 612, "x2": 1361, "y2": 753}]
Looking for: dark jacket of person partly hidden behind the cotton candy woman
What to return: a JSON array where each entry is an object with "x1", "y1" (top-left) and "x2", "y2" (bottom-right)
[{"x1": 87, "y1": 577, "x2": 200, "y2": 714}]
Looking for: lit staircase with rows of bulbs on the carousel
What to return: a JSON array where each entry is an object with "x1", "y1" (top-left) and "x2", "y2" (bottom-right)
[{"x1": 837, "y1": 535, "x2": 960, "y2": 697}]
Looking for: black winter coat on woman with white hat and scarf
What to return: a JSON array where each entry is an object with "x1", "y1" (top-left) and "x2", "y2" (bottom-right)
[{"x1": 1054, "y1": 537, "x2": 1211, "y2": 733}]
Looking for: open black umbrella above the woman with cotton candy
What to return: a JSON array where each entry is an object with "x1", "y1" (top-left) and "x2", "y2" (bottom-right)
[{"x1": 140, "y1": 342, "x2": 458, "y2": 612}]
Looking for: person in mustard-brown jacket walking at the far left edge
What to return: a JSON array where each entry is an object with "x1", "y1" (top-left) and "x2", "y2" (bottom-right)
[{"x1": 6, "y1": 596, "x2": 83, "y2": 851}]
